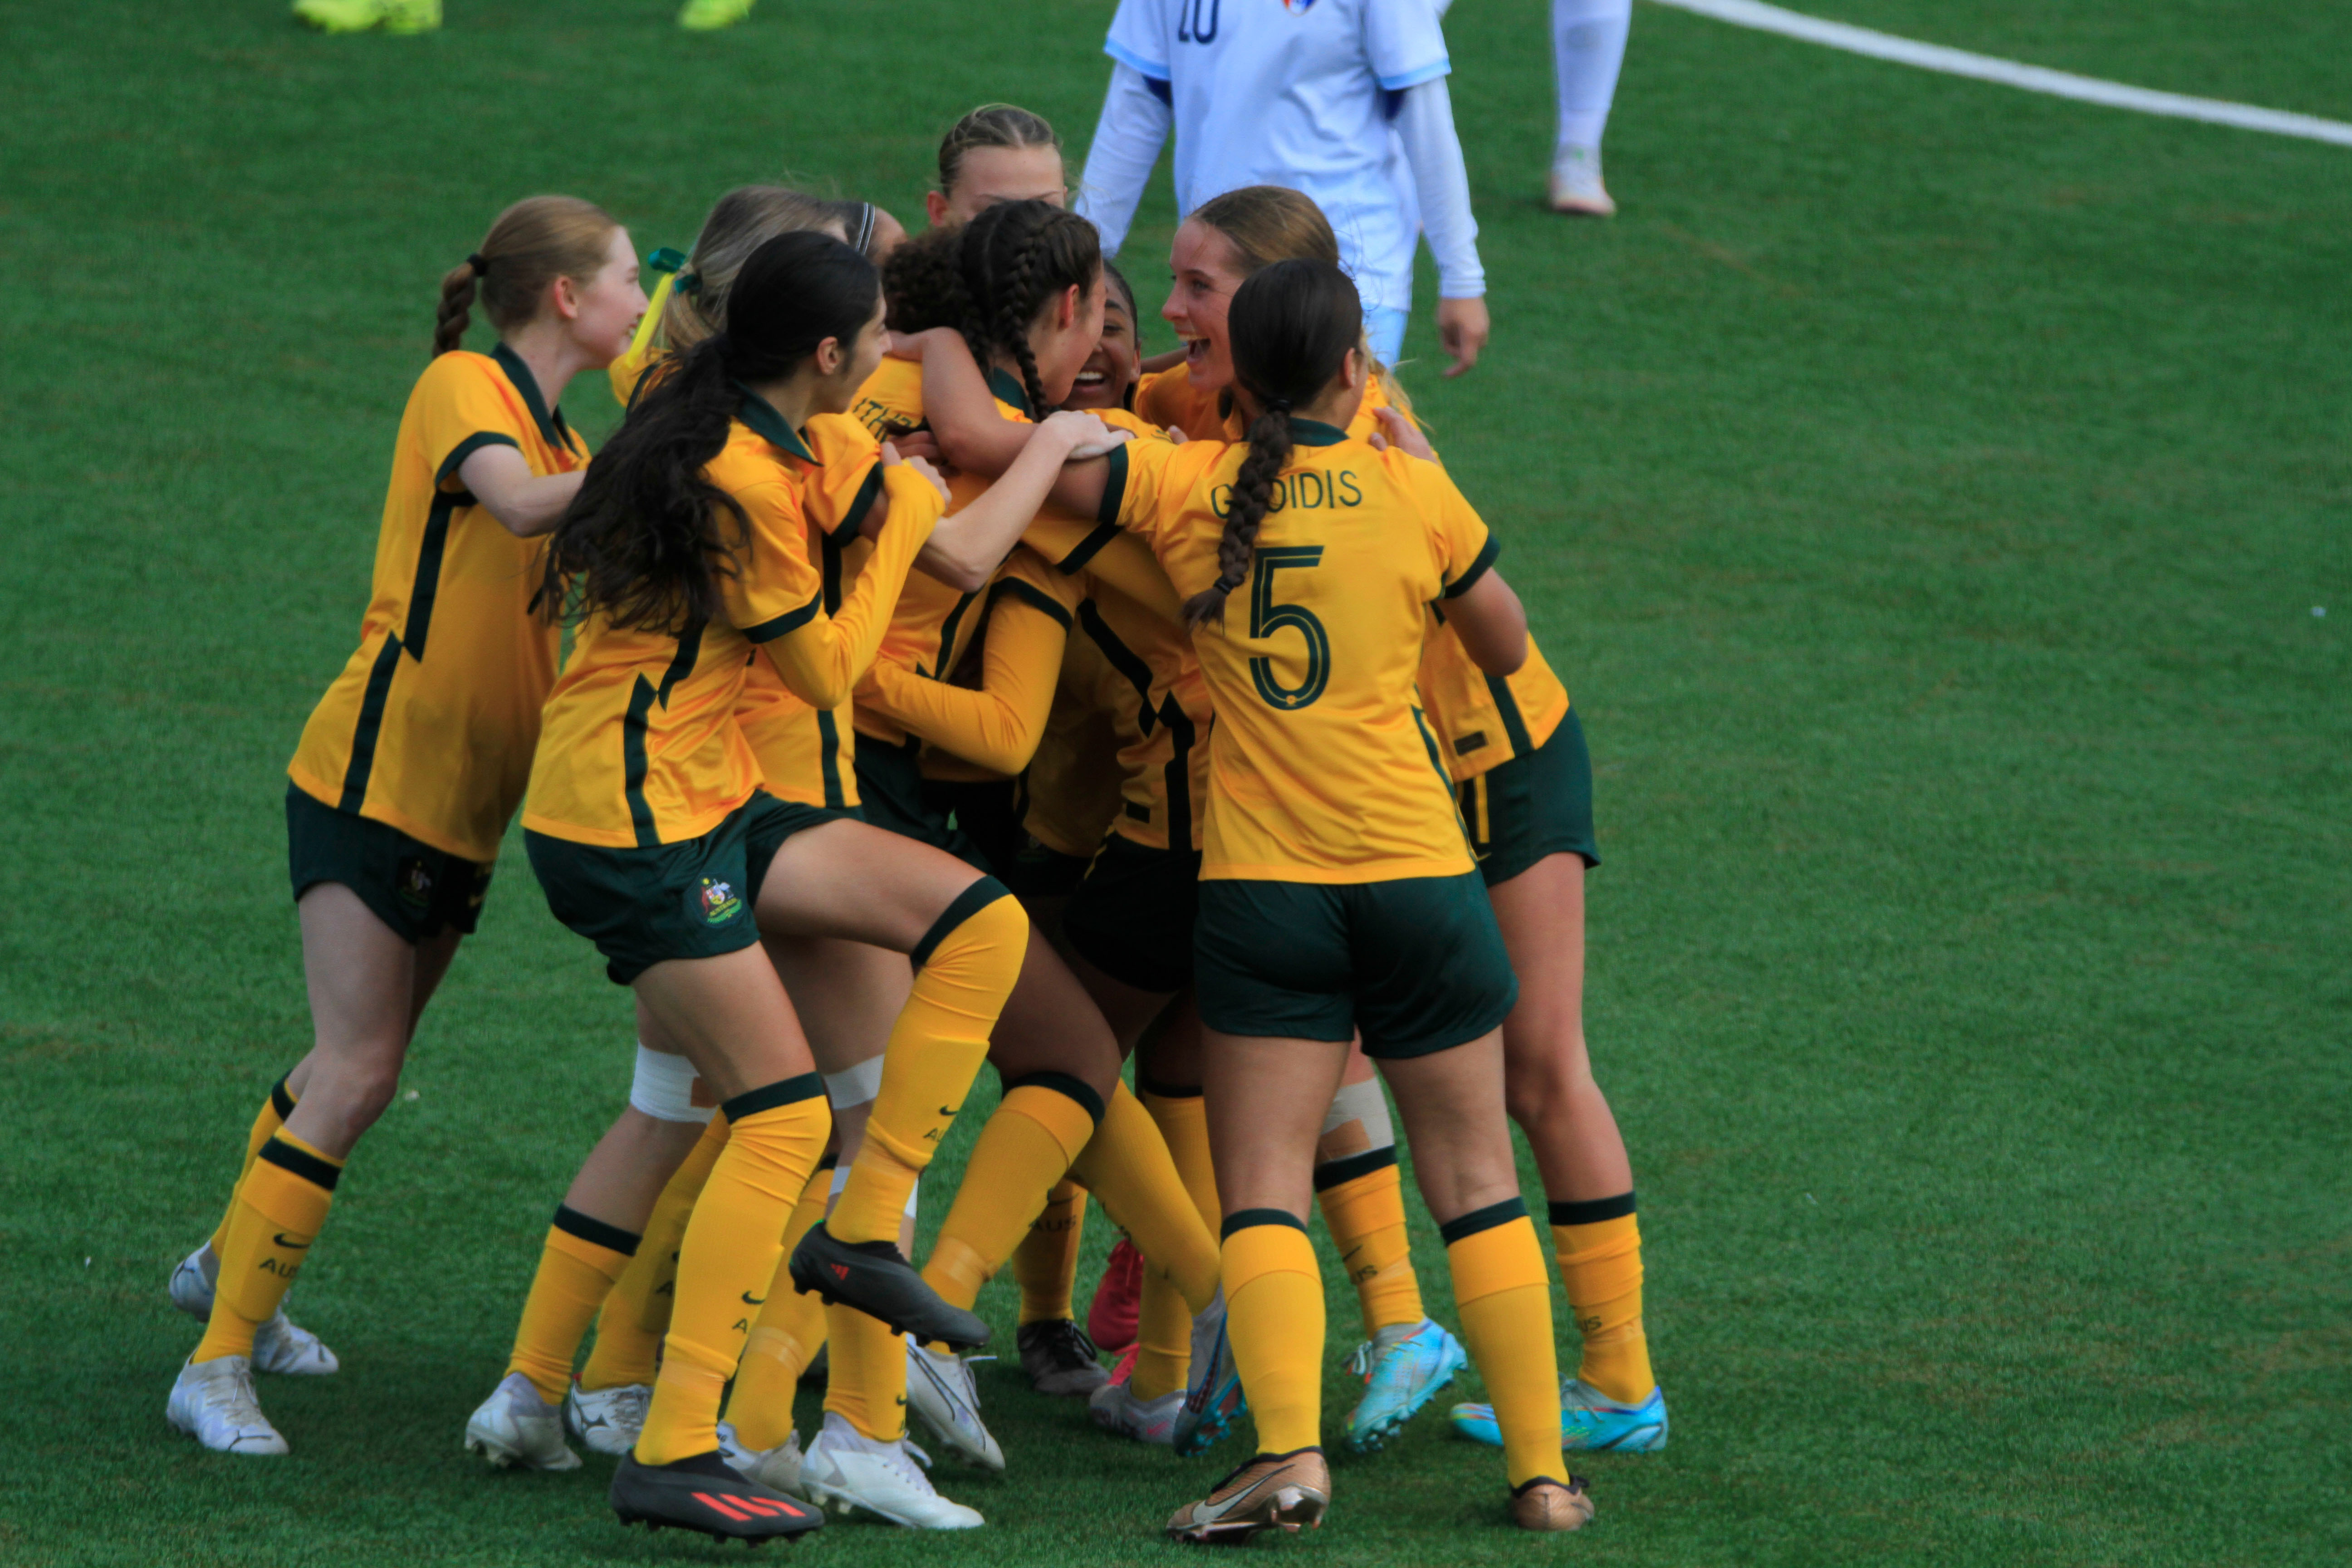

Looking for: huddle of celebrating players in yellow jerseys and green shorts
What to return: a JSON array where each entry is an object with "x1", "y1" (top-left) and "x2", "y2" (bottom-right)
[{"x1": 169, "y1": 95, "x2": 1667, "y2": 1542}]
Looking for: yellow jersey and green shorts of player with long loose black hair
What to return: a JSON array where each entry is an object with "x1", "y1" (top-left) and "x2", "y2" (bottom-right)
[{"x1": 522, "y1": 392, "x2": 941, "y2": 985}]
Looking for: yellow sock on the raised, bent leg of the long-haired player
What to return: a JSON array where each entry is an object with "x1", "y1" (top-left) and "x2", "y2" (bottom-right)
[{"x1": 826, "y1": 877, "x2": 1028, "y2": 1244}]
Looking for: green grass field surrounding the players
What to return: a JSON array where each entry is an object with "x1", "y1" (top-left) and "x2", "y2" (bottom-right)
[{"x1": 0, "y1": 0, "x2": 2352, "y2": 1568}]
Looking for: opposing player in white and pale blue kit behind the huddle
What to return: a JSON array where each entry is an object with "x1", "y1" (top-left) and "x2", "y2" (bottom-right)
[{"x1": 1077, "y1": 0, "x2": 1489, "y2": 376}]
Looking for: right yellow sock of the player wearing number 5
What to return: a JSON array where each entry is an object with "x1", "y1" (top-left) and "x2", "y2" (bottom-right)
[{"x1": 1437, "y1": 1199, "x2": 1569, "y2": 1488}]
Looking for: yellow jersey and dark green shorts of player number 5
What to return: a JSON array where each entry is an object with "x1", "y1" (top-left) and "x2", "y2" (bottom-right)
[{"x1": 1101, "y1": 421, "x2": 1517, "y2": 1055}]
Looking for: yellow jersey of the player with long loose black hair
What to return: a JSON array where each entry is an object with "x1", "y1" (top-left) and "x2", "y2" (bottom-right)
[{"x1": 522, "y1": 392, "x2": 941, "y2": 848}]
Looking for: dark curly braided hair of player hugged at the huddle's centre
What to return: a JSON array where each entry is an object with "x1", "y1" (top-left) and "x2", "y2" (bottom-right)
[{"x1": 882, "y1": 202, "x2": 1103, "y2": 418}]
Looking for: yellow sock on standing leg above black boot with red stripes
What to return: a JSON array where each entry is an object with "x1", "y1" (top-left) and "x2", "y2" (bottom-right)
[{"x1": 637, "y1": 1072, "x2": 833, "y2": 1465}]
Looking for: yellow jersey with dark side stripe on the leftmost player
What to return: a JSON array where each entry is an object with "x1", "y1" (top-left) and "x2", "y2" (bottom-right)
[{"x1": 287, "y1": 343, "x2": 588, "y2": 863}]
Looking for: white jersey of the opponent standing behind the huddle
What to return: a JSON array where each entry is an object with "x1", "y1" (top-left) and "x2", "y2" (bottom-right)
[{"x1": 1103, "y1": 0, "x2": 1451, "y2": 310}]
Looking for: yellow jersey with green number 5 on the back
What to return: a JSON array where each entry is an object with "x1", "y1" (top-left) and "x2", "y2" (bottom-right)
[{"x1": 1103, "y1": 421, "x2": 1494, "y2": 882}]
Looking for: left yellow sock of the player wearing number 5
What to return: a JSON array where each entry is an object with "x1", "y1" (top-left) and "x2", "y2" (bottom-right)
[{"x1": 1223, "y1": 1208, "x2": 1336, "y2": 1453}]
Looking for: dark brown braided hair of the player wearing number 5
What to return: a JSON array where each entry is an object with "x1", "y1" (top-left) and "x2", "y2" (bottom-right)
[{"x1": 1183, "y1": 261, "x2": 1364, "y2": 625}]
